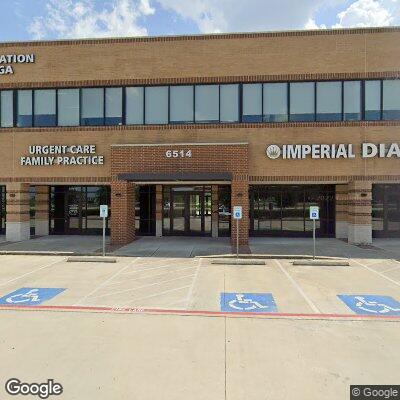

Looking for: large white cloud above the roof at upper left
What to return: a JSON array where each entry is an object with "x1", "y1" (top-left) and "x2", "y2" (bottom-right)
[{"x1": 28, "y1": 0, "x2": 155, "y2": 39}]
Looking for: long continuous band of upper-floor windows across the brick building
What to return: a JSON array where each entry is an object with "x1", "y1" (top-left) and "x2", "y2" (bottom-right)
[{"x1": 0, "y1": 79, "x2": 400, "y2": 128}]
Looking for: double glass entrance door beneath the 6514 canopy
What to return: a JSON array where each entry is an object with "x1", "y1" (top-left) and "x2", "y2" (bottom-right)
[{"x1": 163, "y1": 186, "x2": 211, "y2": 236}]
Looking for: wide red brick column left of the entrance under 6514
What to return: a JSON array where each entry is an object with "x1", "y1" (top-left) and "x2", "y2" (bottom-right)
[{"x1": 111, "y1": 181, "x2": 135, "y2": 244}]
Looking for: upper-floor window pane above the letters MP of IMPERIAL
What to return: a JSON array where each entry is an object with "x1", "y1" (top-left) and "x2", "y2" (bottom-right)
[{"x1": 290, "y1": 82, "x2": 315, "y2": 122}]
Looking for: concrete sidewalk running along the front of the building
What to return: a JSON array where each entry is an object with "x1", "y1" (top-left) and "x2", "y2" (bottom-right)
[{"x1": 0, "y1": 235, "x2": 400, "y2": 259}]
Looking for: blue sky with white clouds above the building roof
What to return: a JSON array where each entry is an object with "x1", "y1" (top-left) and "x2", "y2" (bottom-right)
[{"x1": 0, "y1": 0, "x2": 400, "y2": 42}]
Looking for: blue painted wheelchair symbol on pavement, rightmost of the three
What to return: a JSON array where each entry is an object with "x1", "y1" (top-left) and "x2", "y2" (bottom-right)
[{"x1": 338, "y1": 294, "x2": 400, "y2": 315}]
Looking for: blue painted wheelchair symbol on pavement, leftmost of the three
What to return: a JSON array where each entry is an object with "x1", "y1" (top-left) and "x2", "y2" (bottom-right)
[{"x1": 0, "y1": 288, "x2": 65, "y2": 306}]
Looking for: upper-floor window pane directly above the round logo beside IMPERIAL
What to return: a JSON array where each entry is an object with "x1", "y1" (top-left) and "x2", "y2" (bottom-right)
[{"x1": 263, "y1": 83, "x2": 288, "y2": 122}]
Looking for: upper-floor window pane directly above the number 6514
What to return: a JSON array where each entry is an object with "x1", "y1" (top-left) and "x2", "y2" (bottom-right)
[{"x1": 170, "y1": 86, "x2": 194, "y2": 124}]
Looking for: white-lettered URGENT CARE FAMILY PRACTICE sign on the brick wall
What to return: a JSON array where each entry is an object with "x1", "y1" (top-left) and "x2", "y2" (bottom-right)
[{"x1": 20, "y1": 144, "x2": 104, "y2": 167}]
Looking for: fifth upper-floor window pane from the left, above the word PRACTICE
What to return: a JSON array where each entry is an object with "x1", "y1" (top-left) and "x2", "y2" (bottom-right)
[{"x1": 81, "y1": 88, "x2": 104, "y2": 126}]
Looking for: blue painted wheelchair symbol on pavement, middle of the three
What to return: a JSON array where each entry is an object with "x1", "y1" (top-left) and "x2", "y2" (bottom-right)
[{"x1": 221, "y1": 293, "x2": 278, "y2": 313}]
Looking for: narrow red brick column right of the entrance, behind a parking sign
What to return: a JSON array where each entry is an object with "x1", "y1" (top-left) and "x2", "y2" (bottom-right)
[{"x1": 231, "y1": 177, "x2": 249, "y2": 246}]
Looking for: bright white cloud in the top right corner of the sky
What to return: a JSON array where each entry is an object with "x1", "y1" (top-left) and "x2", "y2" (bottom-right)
[{"x1": 333, "y1": 0, "x2": 399, "y2": 28}]
